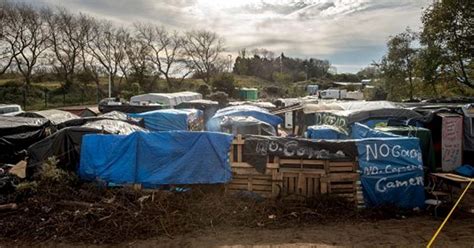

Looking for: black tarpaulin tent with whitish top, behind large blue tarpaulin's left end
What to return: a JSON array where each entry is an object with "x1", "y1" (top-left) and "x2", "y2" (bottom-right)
[{"x1": 28, "y1": 120, "x2": 146, "y2": 175}]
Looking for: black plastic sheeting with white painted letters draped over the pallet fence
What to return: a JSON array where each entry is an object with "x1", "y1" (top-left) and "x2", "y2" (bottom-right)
[{"x1": 243, "y1": 135, "x2": 358, "y2": 173}]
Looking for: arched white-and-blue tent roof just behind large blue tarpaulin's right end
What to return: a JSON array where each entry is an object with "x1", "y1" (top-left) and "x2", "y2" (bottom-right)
[{"x1": 206, "y1": 105, "x2": 283, "y2": 131}]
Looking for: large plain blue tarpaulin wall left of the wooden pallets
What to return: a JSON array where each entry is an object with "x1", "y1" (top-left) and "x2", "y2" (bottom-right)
[{"x1": 79, "y1": 131, "x2": 232, "y2": 187}]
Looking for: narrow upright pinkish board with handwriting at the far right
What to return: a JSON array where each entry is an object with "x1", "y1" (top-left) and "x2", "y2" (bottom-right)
[{"x1": 441, "y1": 115, "x2": 463, "y2": 171}]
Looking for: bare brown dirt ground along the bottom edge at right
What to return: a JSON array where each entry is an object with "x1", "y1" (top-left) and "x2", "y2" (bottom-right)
[{"x1": 6, "y1": 215, "x2": 474, "y2": 248}]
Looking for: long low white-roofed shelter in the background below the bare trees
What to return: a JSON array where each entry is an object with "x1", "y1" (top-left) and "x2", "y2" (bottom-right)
[{"x1": 130, "y1": 91, "x2": 202, "y2": 107}]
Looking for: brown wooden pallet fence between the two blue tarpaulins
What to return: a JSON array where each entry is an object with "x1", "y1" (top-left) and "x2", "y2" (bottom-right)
[{"x1": 226, "y1": 135, "x2": 363, "y2": 205}]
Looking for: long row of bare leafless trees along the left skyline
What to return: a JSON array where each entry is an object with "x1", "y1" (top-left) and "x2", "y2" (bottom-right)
[{"x1": 0, "y1": 1, "x2": 225, "y2": 101}]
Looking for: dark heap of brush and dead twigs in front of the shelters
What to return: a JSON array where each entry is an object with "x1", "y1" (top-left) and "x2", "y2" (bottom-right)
[{"x1": 0, "y1": 159, "x2": 363, "y2": 244}]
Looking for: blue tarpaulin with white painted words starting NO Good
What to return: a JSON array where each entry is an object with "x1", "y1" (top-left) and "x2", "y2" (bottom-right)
[{"x1": 356, "y1": 137, "x2": 425, "y2": 209}]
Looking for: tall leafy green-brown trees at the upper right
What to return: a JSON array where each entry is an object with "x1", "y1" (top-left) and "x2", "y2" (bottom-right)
[{"x1": 374, "y1": 0, "x2": 474, "y2": 100}]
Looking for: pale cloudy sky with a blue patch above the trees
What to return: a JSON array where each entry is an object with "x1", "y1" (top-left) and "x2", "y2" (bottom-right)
[{"x1": 22, "y1": 0, "x2": 432, "y2": 73}]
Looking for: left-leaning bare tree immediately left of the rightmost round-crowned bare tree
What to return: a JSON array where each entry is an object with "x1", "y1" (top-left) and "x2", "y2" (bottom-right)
[{"x1": 135, "y1": 24, "x2": 191, "y2": 88}]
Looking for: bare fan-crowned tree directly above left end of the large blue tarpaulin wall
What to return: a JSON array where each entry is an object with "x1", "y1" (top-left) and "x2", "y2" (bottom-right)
[{"x1": 88, "y1": 21, "x2": 129, "y2": 97}]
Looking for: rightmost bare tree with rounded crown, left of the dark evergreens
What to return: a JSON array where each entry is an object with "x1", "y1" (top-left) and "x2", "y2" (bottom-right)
[{"x1": 184, "y1": 30, "x2": 224, "y2": 84}]
